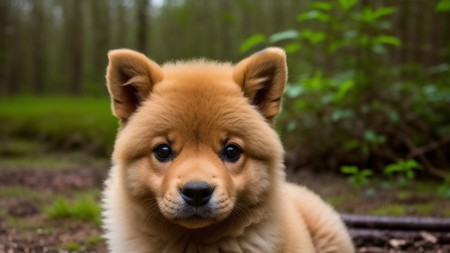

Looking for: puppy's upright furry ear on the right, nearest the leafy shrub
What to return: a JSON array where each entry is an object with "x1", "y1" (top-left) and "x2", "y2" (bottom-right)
[{"x1": 233, "y1": 47, "x2": 287, "y2": 125}]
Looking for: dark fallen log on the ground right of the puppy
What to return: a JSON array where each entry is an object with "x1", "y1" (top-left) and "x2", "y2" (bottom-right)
[{"x1": 341, "y1": 214, "x2": 450, "y2": 233}]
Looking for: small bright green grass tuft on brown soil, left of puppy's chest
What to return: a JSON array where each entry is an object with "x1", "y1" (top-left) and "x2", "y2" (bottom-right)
[{"x1": 44, "y1": 196, "x2": 100, "y2": 224}]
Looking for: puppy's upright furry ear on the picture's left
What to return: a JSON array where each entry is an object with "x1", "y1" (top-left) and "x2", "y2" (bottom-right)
[{"x1": 106, "y1": 49, "x2": 163, "y2": 123}]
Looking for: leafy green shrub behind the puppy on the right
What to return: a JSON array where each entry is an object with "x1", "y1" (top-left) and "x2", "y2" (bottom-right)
[{"x1": 241, "y1": 0, "x2": 450, "y2": 181}]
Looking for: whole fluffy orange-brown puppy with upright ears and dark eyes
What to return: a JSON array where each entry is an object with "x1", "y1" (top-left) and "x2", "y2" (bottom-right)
[{"x1": 103, "y1": 48, "x2": 354, "y2": 253}]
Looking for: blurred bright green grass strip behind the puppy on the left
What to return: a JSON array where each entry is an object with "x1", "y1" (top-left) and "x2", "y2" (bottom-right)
[{"x1": 0, "y1": 97, "x2": 117, "y2": 154}]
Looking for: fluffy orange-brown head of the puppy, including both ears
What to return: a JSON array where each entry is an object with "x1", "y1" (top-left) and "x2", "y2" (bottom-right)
[{"x1": 106, "y1": 48, "x2": 287, "y2": 228}]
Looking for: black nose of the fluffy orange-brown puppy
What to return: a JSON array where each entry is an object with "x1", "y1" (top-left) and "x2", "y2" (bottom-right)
[{"x1": 180, "y1": 182, "x2": 214, "y2": 206}]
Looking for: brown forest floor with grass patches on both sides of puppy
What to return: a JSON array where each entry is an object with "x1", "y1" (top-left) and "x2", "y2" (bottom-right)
[{"x1": 0, "y1": 137, "x2": 450, "y2": 253}]
